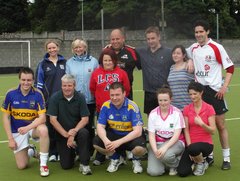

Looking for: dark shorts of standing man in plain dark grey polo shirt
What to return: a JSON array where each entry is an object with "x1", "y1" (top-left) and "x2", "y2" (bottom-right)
[{"x1": 144, "y1": 91, "x2": 158, "y2": 115}]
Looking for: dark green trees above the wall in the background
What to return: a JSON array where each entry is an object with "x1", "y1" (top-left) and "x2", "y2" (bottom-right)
[{"x1": 0, "y1": 0, "x2": 240, "y2": 38}]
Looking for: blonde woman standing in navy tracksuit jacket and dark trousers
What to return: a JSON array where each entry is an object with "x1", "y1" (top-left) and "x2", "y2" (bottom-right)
[{"x1": 35, "y1": 40, "x2": 66, "y2": 161}]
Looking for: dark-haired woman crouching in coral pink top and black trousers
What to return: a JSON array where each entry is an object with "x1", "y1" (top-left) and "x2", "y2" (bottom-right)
[{"x1": 177, "y1": 82, "x2": 216, "y2": 177}]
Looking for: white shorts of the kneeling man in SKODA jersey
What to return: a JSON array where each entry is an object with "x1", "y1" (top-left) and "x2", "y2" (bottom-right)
[{"x1": 12, "y1": 129, "x2": 38, "y2": 154}]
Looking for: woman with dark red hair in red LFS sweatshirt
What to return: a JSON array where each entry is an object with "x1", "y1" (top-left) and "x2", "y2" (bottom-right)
[{"x1": 90, "y1": 48, "x2": 130, "y2": 113}]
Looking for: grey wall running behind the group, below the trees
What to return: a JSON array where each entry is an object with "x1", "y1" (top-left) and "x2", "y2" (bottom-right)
[{"x1": 0, "y1": 30, "x2": 240, "y2": 73}]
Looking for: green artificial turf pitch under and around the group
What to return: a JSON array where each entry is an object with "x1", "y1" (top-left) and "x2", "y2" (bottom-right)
[{"x1": 0, "y1": 68, "x2": 240, "y2": 181}]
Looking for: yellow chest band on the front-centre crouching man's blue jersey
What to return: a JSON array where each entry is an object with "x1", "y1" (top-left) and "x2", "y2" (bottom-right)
[{"x1": 108, "y1": 119, "x2": 133, "y2": 131}]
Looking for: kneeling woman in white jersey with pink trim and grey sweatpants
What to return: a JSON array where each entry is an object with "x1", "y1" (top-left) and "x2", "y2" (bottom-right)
[{"x1": 147, "y1": 86, "x2": 185, "y2": 176}]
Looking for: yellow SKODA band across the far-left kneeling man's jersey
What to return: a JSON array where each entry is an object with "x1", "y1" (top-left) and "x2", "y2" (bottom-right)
[{"x1": 11, "y1": 109, "x2": 38, "y2": 121}]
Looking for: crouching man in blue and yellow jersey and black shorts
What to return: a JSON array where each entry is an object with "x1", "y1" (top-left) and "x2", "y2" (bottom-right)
[{"x1": 93, "y1": 82, "x2": 146, "y2": 173}]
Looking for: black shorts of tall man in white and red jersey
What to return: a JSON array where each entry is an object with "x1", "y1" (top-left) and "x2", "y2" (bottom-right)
[{"x1": 203, "y1": 86, "x2": 228, "y2": 115}]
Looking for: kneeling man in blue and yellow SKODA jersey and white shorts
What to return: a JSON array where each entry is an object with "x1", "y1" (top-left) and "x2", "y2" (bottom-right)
[{"x1": 1, "y1": 67, "x2": 49, "y2": 176}]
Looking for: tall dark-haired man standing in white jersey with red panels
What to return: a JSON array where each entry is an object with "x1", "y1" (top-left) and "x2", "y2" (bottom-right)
[{"x1": 187, "y1": 21, "x2": 234, "y2": 170}]
